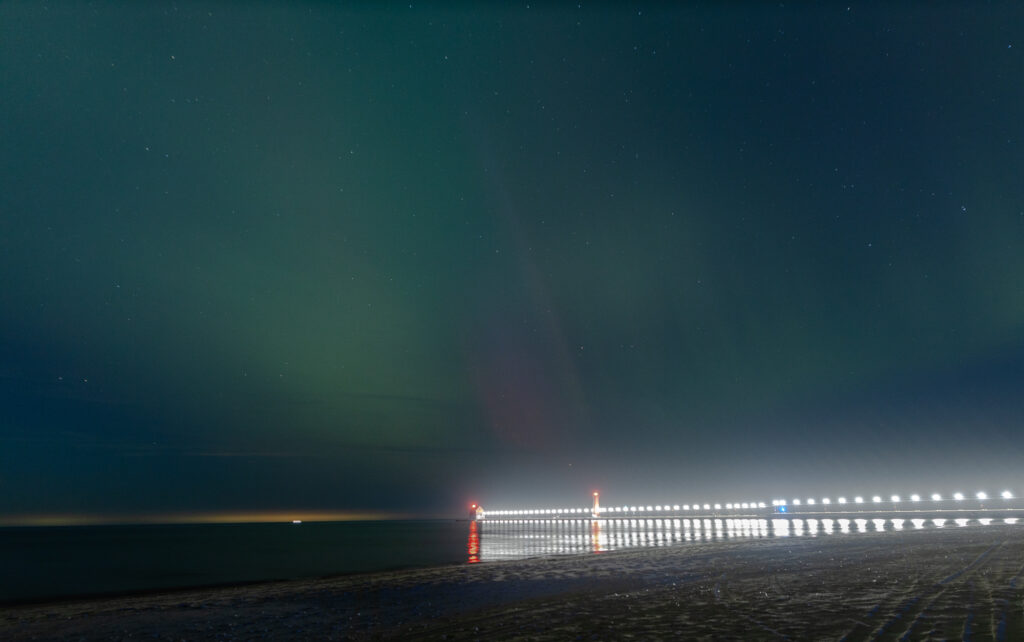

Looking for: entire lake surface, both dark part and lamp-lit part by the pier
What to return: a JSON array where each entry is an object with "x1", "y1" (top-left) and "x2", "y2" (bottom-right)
[{"x1": 0, "y1": 515, "x2": 1021, "y2": 602}]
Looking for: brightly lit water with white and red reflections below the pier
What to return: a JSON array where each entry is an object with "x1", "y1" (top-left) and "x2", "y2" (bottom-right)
[{"x1": 467, "y1": 517, "x2": 1018, "y2": 563}]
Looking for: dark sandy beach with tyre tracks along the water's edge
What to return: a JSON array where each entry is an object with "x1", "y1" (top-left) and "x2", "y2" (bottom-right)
[{"x1": 0, "y1": 525, "x2": 1024, "y2": 640}]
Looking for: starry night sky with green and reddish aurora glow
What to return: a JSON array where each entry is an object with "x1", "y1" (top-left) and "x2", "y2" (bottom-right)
[{"x1": 0, "y1": 2, "x2": 1024, "y2": 521}]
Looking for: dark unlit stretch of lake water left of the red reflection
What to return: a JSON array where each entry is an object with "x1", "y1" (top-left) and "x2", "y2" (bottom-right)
[{"x1": 0, "y1": 520, "x2": 468, "y2": 602}]
